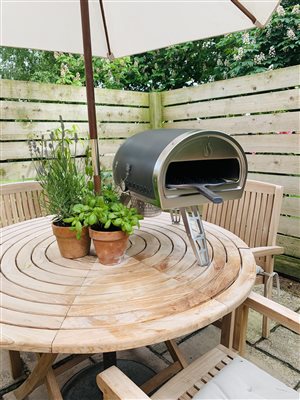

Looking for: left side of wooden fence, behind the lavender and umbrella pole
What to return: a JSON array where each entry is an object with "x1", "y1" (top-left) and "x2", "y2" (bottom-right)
[{"x1": 0, "y1": 80, "x2": 150, "y2": 182}]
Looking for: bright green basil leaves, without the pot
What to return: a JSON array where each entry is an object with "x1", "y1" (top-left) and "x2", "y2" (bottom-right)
[{"x1": 64, "y1": 189, "x2": 143, "y2": 238}]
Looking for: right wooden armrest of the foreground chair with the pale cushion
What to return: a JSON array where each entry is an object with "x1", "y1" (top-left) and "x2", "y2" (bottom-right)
[{"x1": 244, "y1": 292, "x2": 300, "y2": 334}]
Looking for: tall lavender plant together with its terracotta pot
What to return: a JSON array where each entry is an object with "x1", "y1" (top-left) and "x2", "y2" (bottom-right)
[{"x1": 29, "y1": 117, "x2": 93, "y2": 258}]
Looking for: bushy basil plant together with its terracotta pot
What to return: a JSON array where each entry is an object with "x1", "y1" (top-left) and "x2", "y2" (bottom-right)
[{"x1": 65, "y1": 189, "x2": 143, "y2": 265}]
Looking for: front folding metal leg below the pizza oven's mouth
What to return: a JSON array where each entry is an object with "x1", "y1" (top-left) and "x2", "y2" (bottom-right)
[{"x1": 180, "y1": 206, "x2": 210, "y2": 267}]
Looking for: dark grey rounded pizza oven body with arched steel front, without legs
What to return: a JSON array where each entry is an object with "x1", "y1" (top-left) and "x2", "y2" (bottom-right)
[{"x1": 113, "y1": 129, "x2": 247, "y2": 210}]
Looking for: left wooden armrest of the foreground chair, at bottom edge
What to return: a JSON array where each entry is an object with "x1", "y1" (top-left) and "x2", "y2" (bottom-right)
[{"x1": 97, "y1": 366, "x2": 150, "y2": 400}]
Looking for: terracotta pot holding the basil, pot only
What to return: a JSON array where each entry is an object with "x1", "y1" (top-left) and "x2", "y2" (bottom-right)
[{"x1": 89, "y1": 228, "x2": 129, "y2": 265}]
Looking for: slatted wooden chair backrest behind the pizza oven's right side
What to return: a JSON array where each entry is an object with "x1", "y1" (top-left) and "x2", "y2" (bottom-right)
[{"x1": 202, "y1": 180, "x2": 283, "y2": 266}]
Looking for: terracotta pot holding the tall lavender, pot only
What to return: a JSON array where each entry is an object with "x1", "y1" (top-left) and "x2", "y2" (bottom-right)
[{"x1": 52, "y1": 224, "x2": 91, "y2": 258}]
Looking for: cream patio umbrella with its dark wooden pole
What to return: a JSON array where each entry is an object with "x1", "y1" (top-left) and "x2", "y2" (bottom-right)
[{"x1": 0, "y1": 0, "x2": 279, "y2": 191}]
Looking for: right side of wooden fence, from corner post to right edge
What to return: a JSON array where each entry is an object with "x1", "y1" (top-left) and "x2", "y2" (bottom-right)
[{"x1": 162, "y1": 65, "x2": 300, "y2": 278}]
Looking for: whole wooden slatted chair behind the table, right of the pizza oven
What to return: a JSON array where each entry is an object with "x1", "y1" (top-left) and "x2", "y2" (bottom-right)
[{"x1": 202, "y1": 180, "x2": 284, "y2": 337}]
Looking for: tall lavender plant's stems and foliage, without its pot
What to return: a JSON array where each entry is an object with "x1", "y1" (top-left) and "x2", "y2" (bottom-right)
[{"x1": 28, "y1": 117, "x2": 93, "y2": 226}]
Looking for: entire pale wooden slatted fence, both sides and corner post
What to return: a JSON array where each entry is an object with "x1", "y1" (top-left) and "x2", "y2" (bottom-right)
[{"x1": 0, "y1": 66, "x2": 300, "y2": 276}]
